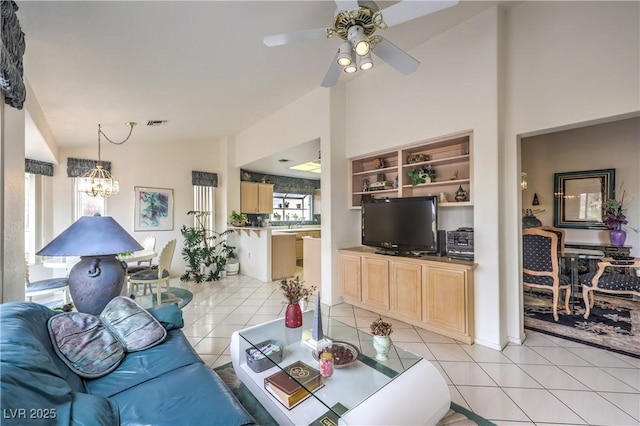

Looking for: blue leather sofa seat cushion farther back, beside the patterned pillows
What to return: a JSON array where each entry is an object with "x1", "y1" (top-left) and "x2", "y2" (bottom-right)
[{"x1": 86, "y1": 330, "x2": 202, "y2": 398}]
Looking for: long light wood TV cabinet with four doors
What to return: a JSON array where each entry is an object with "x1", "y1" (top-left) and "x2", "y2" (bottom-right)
[{"x1": 338, "y1": 247, "x2": 476, "y2": 344}]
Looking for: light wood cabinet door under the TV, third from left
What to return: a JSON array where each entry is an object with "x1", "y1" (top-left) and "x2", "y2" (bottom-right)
[{"x1": 389, "y1": 261, "x2": 422, "y2": 320}]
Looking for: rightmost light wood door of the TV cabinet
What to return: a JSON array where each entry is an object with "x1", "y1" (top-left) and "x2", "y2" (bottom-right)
[{"x1": 422, "y1": 266, "x2": 468, "y2": 334}]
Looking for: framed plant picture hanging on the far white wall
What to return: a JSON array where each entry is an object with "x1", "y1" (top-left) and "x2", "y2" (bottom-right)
[{"x1": 133, "y1": 186, "x2": 173, "y2": 231}]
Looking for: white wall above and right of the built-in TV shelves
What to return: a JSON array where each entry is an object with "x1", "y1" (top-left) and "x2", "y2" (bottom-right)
[{"x1": 344, "y1": 8, "x2": 504, "y2": 349}]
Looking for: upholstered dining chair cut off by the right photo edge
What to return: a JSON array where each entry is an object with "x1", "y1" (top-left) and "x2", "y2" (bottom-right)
[{"x1": 580, "y1": 257, "x2": 640, "y2": 319}]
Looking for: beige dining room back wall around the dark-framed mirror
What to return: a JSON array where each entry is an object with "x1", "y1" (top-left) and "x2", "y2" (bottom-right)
[{"x1": 521, "y1": 118, "x2": 640, "y2": 256}]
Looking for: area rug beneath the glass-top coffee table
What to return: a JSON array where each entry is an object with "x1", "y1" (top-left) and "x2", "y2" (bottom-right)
[{"x1": 213, "y1": 362, "x2": 493, "y2": 426}]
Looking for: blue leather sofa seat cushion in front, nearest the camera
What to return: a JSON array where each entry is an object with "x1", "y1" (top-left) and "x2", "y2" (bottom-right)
[{"x1": 111, "y1": 362, "x2": 255, "y2": 426}]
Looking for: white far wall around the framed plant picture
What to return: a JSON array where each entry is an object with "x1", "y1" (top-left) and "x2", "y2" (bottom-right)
[{"x1": 50, "y1": 137, "x2": 226, "y2": 274}]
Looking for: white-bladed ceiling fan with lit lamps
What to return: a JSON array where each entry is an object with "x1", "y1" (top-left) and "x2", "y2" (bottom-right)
[{"x1": 263, "y1": 0, "x2": 458, "y2": 87}]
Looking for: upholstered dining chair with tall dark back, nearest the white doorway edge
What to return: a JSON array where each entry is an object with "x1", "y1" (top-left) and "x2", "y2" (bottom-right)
[{"x1": 522, "y1": 228, "x2": 571, "y2": 321}]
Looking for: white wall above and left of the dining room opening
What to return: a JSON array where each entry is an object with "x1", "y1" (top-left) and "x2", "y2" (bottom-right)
[{"x1": 500, "y1": 1, "x2": 640, "y2": 341}]
